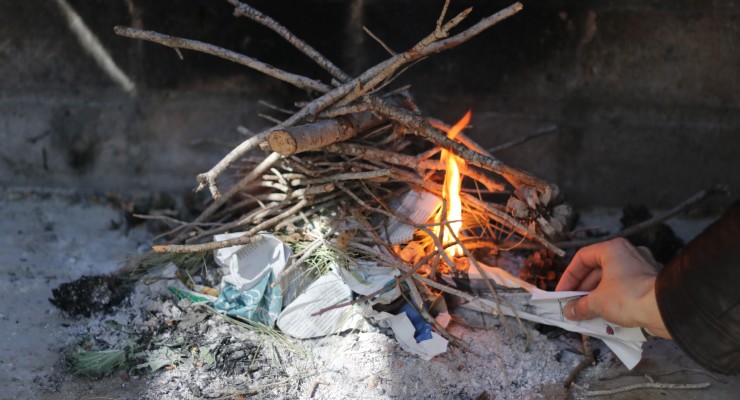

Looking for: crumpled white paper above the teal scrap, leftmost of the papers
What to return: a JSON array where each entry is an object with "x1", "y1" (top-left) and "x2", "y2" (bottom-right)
[{"x1": 214, "y1": 232, "x2": 291, "y2": 292}]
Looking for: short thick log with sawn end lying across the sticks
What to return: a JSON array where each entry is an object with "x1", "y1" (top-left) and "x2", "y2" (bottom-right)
[{"x1": 267, "y1": 111, "x2": 385, "y2": 156}]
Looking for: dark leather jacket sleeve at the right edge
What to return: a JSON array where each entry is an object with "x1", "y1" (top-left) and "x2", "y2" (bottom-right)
[{"x1": 655, "y1": 201, "x2": 740, "y2": 374}]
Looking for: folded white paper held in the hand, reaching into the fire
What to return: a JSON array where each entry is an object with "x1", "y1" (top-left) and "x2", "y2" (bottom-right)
[{"x1": 463, "y1": 263, "x2": 645, "y2": 369}]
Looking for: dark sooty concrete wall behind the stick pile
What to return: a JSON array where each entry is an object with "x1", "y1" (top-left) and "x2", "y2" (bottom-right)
[{"x1": 0, "y1": 0, "x2": 740, "y2": 211}]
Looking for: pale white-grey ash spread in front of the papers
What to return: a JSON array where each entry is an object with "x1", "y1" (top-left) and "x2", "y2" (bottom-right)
[{"x1": 55, "y1": 281, "x2": 581, "y2": 400}]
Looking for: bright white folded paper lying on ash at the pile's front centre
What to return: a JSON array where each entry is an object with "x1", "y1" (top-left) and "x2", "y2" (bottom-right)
[{"x1": 277, "y1": 269, "x2": 365, "y2": 339}]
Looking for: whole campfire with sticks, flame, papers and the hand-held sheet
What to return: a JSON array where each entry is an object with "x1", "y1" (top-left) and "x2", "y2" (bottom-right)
[{"x1": 43, "y1": 0, "x2": 711, "y2": 392}]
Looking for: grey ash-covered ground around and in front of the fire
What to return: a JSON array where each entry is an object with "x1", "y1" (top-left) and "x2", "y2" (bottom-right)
[{"x1": 0, "y1": 190, "x2": 740, "y2": 400}]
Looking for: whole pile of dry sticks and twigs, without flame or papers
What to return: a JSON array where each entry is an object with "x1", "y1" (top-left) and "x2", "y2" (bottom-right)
[{"x1": 115, "y1": 0, "x2": 584, "y2": 347}]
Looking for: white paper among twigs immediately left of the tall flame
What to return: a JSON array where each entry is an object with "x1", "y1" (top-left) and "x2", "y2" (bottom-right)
[{"x1": 388, "y1": 190, "x2": 442, "y2": 245}]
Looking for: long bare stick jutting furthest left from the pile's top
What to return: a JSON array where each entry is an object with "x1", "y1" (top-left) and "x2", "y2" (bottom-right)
[{"x1": 113, "y1": 26, "x2": 331, "y2": 93}]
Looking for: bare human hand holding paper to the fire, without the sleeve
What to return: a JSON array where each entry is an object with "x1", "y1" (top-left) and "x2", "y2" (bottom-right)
[{"x1": 555, "y1": 238, "x2": 670, "y2": 339}]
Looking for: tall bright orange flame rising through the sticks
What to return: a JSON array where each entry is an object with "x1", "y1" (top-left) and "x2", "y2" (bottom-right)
[{"x1": 435, "y1": 110, "x2": 471, "y2": 257}]
